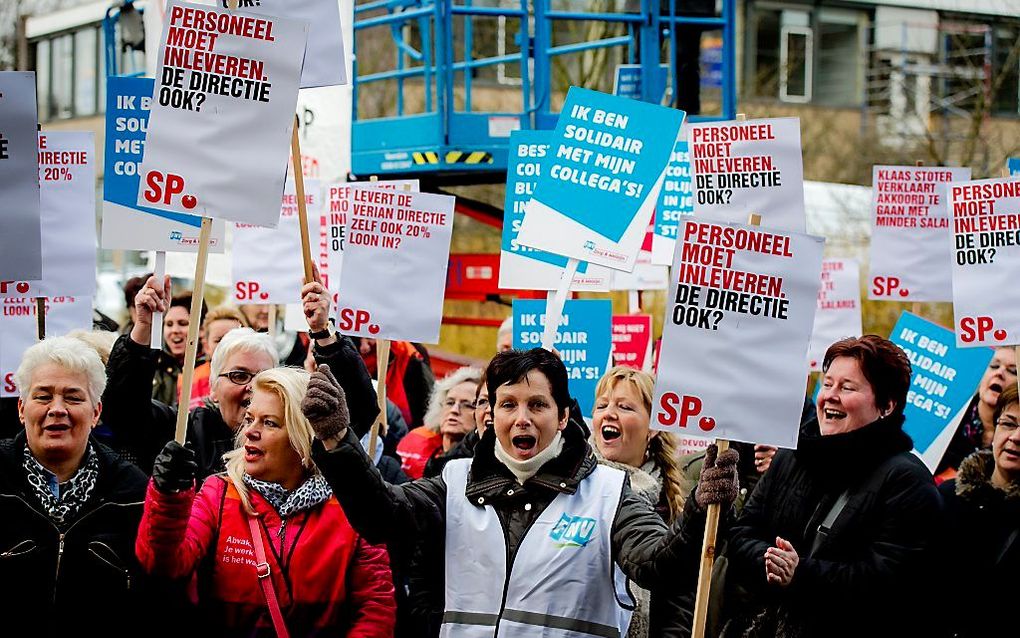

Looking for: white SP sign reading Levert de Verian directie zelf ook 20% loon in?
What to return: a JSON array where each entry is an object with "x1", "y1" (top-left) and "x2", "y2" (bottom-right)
[{"x1": 337, "y1": 188, "x2": 455, "y2": 343}]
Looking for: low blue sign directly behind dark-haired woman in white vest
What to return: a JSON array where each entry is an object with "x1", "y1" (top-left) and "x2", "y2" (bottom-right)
[{"x1": 513, "y1": 299, "x2": 613, "y2": 416}]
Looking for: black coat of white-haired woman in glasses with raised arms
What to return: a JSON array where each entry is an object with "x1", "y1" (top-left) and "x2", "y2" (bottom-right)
[{"x1": 103, "y1": 335, "x2": 379, "y2": 473}]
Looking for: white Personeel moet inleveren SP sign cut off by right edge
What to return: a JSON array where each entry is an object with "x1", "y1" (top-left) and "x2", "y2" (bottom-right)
[{"x1": 949, "y1": 178, "x2": 1020, "y2": 347}]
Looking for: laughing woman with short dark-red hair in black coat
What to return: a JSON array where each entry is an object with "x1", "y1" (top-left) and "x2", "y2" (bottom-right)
[{"x1": 723, "y1": 335, "x2": 940, "y2": 637}]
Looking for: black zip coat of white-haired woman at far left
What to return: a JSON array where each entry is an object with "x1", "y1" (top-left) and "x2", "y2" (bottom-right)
[{"x1": 0, "y1": 433, "x2": 155, "y2": 637}]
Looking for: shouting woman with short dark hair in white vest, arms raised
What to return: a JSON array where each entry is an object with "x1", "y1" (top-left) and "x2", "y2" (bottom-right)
[{"x1": 304, "y1": 349, "x2": 736, "y2": 638}]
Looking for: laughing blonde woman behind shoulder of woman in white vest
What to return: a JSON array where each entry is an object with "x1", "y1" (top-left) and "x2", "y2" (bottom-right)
[{"x1": 592, "y1": 365, "x2": 694, "y2": 638}]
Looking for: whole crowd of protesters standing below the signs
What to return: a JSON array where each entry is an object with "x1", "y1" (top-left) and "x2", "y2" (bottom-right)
[{"x1": 0, "y1": 276, "x2": 1020, "y2": 638}]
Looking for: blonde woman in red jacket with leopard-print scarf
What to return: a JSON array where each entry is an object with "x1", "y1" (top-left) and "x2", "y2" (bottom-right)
[{"x1": 136, "y1": 367, "x2": 396, "y2": 638}]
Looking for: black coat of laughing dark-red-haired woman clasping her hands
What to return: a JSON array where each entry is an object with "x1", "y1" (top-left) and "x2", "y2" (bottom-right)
[{"x1": 723, "y1": 415, "x2": 941, "y2": 638}]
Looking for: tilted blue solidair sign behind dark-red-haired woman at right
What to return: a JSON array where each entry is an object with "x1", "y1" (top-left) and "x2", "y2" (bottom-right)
[{"x1": 889, "y1": 312, "x2": 992, "y2": 470}]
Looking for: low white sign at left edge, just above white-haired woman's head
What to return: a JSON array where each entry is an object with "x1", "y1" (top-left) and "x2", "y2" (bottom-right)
[{"x1": 0, "y1": 297, "x2": 92, "y2": 397}]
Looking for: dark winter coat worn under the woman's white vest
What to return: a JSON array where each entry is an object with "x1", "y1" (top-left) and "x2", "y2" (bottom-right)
[{"x1": 313, "y1": 423, "x2": 704, "y2": 635}]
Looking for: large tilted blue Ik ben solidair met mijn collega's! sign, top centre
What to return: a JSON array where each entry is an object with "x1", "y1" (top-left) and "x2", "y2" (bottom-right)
[{"x1": 518, "y1": 87, "x2": 684, "y2": 272}]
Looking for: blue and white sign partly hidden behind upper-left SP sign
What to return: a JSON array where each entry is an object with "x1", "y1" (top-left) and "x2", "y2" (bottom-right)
[{"x1": 102, "y1": 76, "x2": 223, "y2": 252}]
